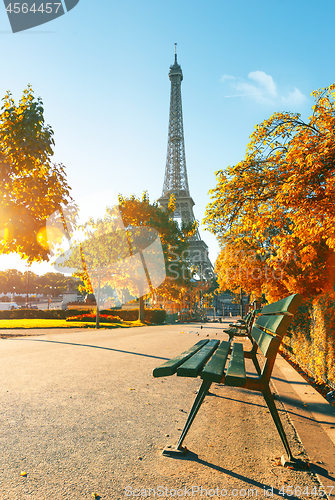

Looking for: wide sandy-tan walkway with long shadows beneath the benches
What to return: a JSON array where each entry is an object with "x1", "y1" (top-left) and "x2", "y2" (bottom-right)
[{"x1": 0, "y1": 324, "x2": 335, "y2": 500}]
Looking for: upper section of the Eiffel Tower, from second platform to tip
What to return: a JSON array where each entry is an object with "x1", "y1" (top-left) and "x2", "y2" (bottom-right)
[{"x1": 162, "y1": 43, "x2": 190, "y2": 197}]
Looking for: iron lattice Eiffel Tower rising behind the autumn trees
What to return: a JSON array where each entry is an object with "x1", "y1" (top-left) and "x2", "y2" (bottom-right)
[{"x1": 158, "y1": 44, "x2": 213, "y2": 280}]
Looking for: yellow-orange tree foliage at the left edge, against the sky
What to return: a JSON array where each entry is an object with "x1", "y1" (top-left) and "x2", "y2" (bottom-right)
[{"x1": 0, "y1": 85, "x2": 72, "y2": 262}]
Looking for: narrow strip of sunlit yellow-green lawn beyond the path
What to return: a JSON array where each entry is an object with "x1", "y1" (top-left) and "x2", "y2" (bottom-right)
[{"x1": 0, "y1": 319, "x2": 142, "y2": 330}]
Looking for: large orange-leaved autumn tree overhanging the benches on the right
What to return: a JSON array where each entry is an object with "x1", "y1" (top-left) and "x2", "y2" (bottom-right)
[{"x1": 205, "y1": 84, "x2": 335, "y2": 301}]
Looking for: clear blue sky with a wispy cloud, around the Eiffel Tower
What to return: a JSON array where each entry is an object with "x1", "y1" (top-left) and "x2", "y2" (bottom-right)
[{"x1": 0, "y1": 0, "x2": 335, "y2": 274}]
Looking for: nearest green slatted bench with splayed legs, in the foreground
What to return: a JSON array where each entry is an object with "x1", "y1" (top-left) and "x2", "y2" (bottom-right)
[{"x1": 153, "y1": 294, "x2": 302, "y2": 464}]
